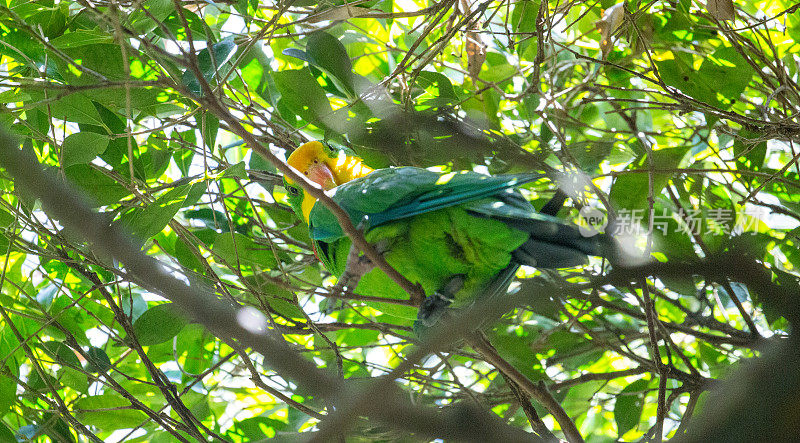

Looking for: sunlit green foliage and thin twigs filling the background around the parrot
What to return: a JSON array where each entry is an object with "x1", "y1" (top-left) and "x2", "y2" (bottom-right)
[{"x1": 0, "y1": 0, "x2": 800, "y2": 442}]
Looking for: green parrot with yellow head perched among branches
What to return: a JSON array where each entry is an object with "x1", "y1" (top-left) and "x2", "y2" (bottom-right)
[{"x1": 284, "y1": 141, "x2": 612, "y2": 331}]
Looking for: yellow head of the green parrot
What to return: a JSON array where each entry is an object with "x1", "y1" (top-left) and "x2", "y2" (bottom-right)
[{"x1": 285, "y1": 141, "x2": 372, "y2": 223}]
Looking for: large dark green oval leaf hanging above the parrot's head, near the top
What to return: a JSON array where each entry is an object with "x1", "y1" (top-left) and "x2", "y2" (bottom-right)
[{"x1": 306, "y1": 31, "x2": 355, "y2": 98}]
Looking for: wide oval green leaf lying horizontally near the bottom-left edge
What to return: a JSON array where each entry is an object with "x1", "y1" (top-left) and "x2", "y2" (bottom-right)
[{"x1": 72, "y1": 394, "x2": 148, "y2": 431}]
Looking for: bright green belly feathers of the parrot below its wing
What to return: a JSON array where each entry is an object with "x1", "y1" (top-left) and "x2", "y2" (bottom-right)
[{"x1": 320, "y1": 207, "x2": 528, "y2": 319}]
